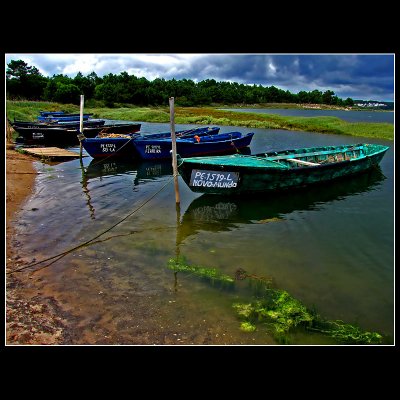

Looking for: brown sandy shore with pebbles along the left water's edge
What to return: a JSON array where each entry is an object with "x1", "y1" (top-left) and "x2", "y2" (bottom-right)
[{"x1": 6, "y1": 145, "x2": 70, "y2": 345}]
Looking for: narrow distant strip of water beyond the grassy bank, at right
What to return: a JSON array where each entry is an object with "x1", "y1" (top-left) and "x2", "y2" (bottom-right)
[{"x1": 225, "y1": 108, "x2": 394, "y2": 124}]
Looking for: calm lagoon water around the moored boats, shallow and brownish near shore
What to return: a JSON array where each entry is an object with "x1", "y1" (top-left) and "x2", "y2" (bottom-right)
[{"x1": 13, "y1": 122, "x2": 394, "y2": 345}]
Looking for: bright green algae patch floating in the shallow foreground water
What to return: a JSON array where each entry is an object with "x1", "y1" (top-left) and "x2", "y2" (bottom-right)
[{"x1": 168, "y1": 257, "x2": 383, "y2": 344}]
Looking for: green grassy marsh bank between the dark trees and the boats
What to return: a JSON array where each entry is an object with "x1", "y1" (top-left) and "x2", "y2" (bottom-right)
[{"x1": 7, "y1": 101, "x2": 394, "y2": 140}]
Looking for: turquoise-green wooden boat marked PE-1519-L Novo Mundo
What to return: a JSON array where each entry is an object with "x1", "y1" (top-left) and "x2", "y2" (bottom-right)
[{"x1": 178, "y1": 143, "x2": 389, "y2": 195}]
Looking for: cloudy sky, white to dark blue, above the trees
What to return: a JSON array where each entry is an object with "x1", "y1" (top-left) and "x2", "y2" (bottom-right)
[{"x1": 5, "y1": 53, "x2": 394, "y2": 101}]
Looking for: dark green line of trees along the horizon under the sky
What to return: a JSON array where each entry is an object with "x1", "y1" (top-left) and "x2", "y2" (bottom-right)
[{"x1": 6, "y1": 60, "x2": 354, "y2": 107}]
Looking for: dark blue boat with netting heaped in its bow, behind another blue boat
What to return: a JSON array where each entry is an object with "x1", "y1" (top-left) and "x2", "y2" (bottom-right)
[{"x1": 81, "y1": 127, "x2": 220, "y2": 160}]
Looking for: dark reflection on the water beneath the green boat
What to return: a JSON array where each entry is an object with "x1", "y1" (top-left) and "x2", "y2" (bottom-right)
[{"x1": 177, "y1": 167, "x2": 386, "y2": 244}]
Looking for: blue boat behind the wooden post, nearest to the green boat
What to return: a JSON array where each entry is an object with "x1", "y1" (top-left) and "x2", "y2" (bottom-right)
[{"x1": 132, "y1": 132, "x2": 254, "y2": 160}]
